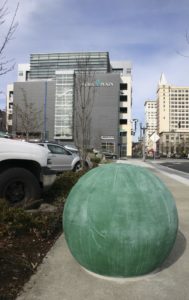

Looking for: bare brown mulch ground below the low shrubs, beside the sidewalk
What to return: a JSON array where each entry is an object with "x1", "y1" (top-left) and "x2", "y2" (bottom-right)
[{"x1": 0, "y1": 226, "x2": 60, "y2": 300}]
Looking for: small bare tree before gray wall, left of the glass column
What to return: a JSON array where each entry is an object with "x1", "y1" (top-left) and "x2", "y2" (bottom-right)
[{"x1": 14, "y1": 89, "x2": 43, "y2": 141}]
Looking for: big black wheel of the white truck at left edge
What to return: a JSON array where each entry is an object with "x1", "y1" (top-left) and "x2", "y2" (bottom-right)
[{"x1": 0, "y1": 168, "x2": 41, "y2": 205}]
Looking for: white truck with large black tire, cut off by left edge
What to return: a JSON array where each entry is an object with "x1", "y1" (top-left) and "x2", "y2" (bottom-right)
[{"x1": 0, "y1": 138, "x2": 56, "y2": 205}]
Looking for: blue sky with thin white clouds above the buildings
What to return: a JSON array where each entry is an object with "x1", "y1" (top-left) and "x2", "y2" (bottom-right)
[{"x1": 0, "y1": 0, "x2": 189, "y2": 132}]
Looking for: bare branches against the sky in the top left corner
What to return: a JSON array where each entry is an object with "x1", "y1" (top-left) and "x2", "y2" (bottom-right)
[{"x1": 0, "y1": 0, "x2": 19, "y2": 76}]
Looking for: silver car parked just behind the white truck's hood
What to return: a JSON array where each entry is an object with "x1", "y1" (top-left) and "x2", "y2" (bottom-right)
[{"x1": 38, "y1": 142, "x2": 81, "y2": 173}]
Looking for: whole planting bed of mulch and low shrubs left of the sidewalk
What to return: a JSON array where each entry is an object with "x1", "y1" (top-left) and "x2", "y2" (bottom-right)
[{"x1": 0, "y1": 172, "x2": 86, "y2": 300}]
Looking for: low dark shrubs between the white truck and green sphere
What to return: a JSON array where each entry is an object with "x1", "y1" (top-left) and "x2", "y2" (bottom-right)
[{"x1": 0, "y1": 171, "x2": 85, "y2": 237}]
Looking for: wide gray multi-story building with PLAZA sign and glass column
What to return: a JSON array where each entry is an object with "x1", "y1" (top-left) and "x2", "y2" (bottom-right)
[{"x1": 7, "y1": 52, "x2": 132, "y2": 157}]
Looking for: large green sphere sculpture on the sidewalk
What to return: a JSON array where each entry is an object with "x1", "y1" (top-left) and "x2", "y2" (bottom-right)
[{"x1": 63, "y1": 163, "x2": 178, "y2": 277}]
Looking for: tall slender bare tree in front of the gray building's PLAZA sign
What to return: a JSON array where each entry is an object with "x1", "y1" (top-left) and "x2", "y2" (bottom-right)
[{"x1": 74, "y1": 56, "x2": 96, "y2": 167}]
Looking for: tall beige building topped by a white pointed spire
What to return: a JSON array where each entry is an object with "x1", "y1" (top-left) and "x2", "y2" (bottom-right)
[{"x1": 157, "y1": 74, "x2": 189, "y2": 155}]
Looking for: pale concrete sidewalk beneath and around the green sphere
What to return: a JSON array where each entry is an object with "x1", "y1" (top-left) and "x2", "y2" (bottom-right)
[{"x1": 17, "y1": 160, "x2": 189, "y2": 300}]
